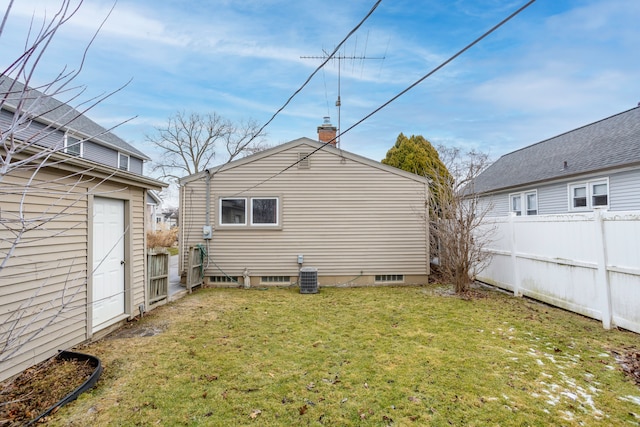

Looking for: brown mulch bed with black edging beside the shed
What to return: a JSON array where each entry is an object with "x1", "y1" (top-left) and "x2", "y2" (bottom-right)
[{"x1": 0, "y1": 357, "x2": 95, "y2": 427}]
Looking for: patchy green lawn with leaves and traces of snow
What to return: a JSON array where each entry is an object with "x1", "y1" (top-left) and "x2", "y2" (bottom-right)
[{"x1": 51, "y1": 286, "x2": 640, "y2": 426}]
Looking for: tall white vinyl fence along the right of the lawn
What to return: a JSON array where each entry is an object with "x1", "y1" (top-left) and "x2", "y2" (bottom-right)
[{"x1": 477, "y1": 210, "x2": 640, "y2": 333}]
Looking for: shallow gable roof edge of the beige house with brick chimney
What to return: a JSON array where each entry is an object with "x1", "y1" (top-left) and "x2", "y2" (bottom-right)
[{"x1": 178, "y1": 137, "x2": 429, "y2": 185}]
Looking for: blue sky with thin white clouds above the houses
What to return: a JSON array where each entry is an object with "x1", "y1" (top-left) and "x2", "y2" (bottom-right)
[{"x1": 0, "y1": 0, "x2": 640, "y2": 174}]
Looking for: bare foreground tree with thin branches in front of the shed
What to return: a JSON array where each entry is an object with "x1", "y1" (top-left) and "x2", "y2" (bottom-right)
[{"x1": 0, "y1": 0, "x2": 135, "y2": 382}]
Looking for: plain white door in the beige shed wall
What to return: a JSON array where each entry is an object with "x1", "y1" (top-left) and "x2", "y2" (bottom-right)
[{"x1": 92, "y1": 197, "x2": 125, "y2": 332}]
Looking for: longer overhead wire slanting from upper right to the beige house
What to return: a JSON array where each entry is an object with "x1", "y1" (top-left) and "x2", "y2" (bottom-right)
[{"x1": 236, "y1": 0, "x2": 536, "y2": 195}]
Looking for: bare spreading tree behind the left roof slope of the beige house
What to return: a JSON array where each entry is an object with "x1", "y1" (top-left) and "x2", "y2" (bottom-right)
[{"x1": 147, "y1": 112, "x2": 266, "y2": 180}]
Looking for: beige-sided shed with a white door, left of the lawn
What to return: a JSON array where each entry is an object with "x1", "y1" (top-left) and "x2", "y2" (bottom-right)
[{"x1": 0, "y1": 154, "x2": 164, "y2": 380}]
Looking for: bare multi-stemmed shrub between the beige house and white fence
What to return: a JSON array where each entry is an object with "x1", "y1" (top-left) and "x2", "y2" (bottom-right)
[{"x1": 429, "y1": 146, "x2": 493, "y2": 293}]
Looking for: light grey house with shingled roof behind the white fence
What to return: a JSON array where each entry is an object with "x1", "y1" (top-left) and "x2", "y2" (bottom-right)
[{"x1": 473, "y1": 107, "x2": 640, "y2": 216}]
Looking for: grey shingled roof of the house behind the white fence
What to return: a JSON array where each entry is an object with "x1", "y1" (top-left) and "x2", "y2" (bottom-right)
[{"x1": 474, "y1": 107, "x2": 640, "y2": 193}]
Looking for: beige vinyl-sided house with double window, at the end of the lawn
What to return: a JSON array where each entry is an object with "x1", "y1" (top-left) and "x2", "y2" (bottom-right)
[{"x1": 179, "y1": 138, "x2": 429, "y2": 286}]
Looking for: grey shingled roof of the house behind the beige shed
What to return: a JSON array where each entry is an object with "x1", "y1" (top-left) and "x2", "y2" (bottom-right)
[{"x1": 0, "y1": 76, "x2": 150, "y2": 160}]
